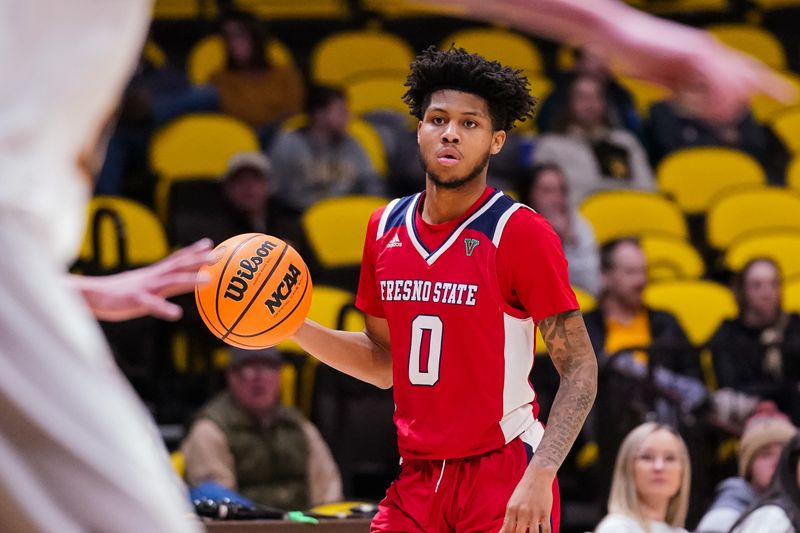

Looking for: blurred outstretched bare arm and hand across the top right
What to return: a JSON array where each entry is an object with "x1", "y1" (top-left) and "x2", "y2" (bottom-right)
[{"x1": 428, "y1": 0, "x2": 794, "y2": 120}]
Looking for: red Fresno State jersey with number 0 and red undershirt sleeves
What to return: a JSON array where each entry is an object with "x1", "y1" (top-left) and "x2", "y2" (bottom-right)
[{"x1": 356, "y1": 188, "x2": 578, "y2": 459}]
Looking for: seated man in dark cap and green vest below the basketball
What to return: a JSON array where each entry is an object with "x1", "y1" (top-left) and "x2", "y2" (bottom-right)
[{"x1": 181, "y1": 348, "x2": 342, "y2": 510}]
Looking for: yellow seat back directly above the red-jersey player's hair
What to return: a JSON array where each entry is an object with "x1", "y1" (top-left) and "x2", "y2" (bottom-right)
[{"x1": 440, "y1": 28, "x2": 544, "y2": 72}]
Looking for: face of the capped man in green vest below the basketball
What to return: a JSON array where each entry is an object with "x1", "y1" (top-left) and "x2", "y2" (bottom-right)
[{"x1": 228, "y1": 361, "x2": 281, "y2": 415}]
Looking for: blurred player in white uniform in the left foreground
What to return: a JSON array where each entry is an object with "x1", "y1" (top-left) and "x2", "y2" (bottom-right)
[{"x1": 0, "y1": 0, "x2": 210, "y2": 533}]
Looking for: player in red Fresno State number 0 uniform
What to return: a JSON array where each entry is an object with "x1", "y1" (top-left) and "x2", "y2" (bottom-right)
[{"x1": 296, "y1": 48, "x2": 597, "y2": 532}]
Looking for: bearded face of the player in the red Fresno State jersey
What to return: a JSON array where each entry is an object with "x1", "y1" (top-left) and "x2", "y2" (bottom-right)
[{"x1": 417, "y1": 89, "x2": 506, "y2": 189}]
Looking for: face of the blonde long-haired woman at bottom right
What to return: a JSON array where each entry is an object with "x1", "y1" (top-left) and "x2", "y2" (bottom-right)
[{"x1": 633, "y1": 429, "x2": 685, "y2": 506}]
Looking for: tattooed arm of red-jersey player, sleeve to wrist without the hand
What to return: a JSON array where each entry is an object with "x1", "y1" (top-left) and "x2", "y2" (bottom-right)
[{"x1": 534, "y1": 311, "x2": 597, "y2": 468}]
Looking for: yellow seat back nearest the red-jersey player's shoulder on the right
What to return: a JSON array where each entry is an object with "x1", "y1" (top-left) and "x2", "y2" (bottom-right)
[{"x1": 580, "y1": 191, "x2": 689, "y2": 244}]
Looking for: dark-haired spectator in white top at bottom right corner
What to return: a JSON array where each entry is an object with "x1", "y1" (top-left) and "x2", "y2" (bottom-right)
[{"x1": 731, "y1": 433, "x2": 800, "y2": 533}]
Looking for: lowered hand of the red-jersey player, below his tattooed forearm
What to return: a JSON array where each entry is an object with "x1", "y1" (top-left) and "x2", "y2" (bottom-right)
[{"x1": 500, "y1": 472, "x2": 553, "y2": 533}]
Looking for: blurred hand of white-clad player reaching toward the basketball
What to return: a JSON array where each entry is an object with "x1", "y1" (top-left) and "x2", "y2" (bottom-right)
[{"x1": 73, "y1": 239, "x2": 212, "y2": 322}]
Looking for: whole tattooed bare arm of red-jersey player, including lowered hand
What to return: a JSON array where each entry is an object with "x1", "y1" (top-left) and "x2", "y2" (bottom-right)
[{"x1": 502, "y1": 310, "x2": 597, "y2": 532}]
